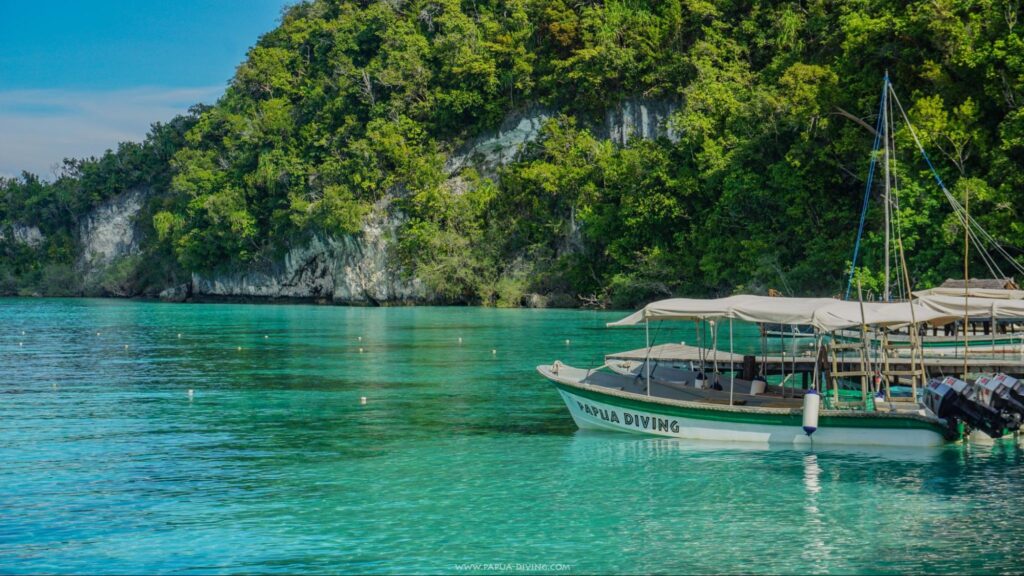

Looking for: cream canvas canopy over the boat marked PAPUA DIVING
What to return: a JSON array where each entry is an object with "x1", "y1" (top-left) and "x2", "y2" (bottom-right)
[{"x1": 608, "y1": 295, "x2": 950, "y2": 332}]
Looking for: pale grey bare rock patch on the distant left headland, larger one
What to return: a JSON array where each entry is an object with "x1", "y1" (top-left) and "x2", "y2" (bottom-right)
[{"x1": 78, "y1": 190, "x2": 148, "y2": 270}]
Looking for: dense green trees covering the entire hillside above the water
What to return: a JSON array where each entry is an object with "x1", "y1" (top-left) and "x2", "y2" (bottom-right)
[{"x1": 0, "y1": 0, "x2": 1024, "y2": 304}]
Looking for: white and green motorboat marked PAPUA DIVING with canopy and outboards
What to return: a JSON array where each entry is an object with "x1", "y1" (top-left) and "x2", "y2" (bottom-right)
[{"x1": 537, "y1": 295, "x2": 1024, "y2": 448}]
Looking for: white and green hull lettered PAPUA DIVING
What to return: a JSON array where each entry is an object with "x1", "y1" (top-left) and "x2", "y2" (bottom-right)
[{"x1": 555, "y1": 381, "x2": 946, "y2": 447}]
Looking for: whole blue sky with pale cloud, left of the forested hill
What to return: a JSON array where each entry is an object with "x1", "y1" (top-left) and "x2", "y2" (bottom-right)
[{"x1": 0, "y1": 0, "x2": 293, "y2": 177}]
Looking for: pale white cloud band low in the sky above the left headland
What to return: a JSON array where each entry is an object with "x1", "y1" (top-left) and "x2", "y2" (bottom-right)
[{"x1": 0, "y1": 86, "x2": 224, "y2": 179}]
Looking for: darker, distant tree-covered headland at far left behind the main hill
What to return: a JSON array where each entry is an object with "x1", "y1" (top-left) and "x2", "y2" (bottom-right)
[{"x1": 0, "y1": 106, "x2": 206, "y2": 295}]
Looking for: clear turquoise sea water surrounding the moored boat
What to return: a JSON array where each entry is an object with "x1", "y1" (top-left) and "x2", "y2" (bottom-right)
[{"x1": 0, "y1": 299, "x2": 1024, "y2": 573}]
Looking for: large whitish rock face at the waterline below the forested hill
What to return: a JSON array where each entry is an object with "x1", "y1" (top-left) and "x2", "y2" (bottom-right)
[{"x1": 188, "y1": 203, "x2": 429, "y2": 305}]
